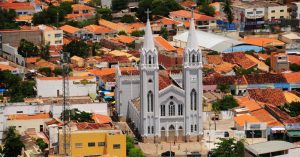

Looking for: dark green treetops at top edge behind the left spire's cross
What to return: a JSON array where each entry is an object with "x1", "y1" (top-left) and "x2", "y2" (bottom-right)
[{"x1": 136, "y1": 0, "x2": 183, "y2": 22}]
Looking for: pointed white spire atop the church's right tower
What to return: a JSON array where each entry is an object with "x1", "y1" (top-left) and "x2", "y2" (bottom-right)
[{"x1": 186, "y1": 11, "x2": 199, "y2": 50}]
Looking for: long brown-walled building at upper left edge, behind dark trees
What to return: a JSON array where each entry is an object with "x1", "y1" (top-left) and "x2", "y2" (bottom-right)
[{"x1": 0, "y1": 30, "x2": 42, "y2": 48}]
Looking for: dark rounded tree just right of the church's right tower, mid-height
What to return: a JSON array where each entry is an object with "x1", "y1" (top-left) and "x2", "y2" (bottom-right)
[{"x1": 212, "y1": 95, "x2": 238, "y2": 111}]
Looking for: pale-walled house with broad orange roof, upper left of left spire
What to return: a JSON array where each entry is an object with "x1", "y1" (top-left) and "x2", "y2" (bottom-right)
[{"x1": 83, "y1": 25, "x2": 117, "y2": 42}]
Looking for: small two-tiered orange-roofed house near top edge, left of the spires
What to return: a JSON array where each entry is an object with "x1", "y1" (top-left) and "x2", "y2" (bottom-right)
[{"x1": 65, "y1": 4, "x2": 96, "y2": 21}]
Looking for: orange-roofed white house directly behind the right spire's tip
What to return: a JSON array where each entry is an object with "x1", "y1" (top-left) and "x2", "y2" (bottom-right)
[{"x1": 169, "y1": 10, "x2": 217, "y2": 30}]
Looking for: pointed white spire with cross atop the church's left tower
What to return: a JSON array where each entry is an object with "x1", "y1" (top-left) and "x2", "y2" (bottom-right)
[{"x1": 143, "y1": 9, "x2": 155, "y2": 50}]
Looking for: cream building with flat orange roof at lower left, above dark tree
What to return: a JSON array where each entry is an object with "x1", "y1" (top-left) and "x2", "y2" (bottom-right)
[{"x1": 6, "y1": 113, "x2": 51, "y2": 134}]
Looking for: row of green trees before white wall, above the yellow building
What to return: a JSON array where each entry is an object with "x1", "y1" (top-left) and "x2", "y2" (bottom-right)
[{"x1": 60, "y1": 108, "x2": 94, "y2": 123}]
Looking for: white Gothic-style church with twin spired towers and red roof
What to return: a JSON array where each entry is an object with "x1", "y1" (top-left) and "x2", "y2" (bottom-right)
[{"x1": 115, "y1": 15, "x2": 203, "y2": 143}]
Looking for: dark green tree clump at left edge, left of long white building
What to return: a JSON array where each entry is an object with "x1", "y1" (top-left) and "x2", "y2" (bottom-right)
[{"x1": 0, "y1": 70, "x2": 36, "y2": 102}]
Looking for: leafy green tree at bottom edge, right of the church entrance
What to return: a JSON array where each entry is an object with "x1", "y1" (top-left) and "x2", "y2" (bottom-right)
[{"x1": 212, "y1": 138, "x2": 244, "y2": 157}]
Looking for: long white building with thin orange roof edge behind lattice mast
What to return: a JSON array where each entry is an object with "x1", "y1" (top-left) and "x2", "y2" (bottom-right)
[{"x1": 36, "y1": 76, "x2": 97, "y2": 97}]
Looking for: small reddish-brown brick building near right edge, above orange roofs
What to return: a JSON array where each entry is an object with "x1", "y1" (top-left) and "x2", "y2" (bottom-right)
[{"x1": 270, "y1": 52, "x2": 290, "y2": 72}]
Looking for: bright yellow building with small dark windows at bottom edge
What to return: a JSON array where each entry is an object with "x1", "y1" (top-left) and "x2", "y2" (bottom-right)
[{"x1": 58, "y1": 122, "x2": 126, "y2": 157}]
